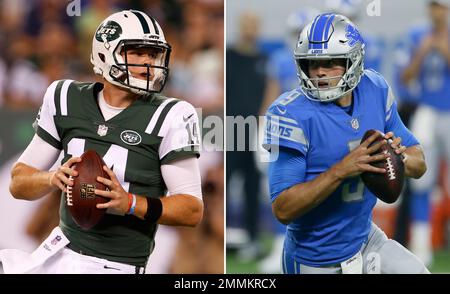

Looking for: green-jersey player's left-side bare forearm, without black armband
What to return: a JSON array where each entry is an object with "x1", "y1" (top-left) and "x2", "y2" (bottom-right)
[{"x1": 9, "y1": 162, "x2": 56, "y2": 200}]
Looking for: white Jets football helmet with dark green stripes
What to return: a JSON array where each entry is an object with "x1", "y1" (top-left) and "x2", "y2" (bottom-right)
[{"x1": 91, "y1": 10, "x2": 171, "y2": 95}]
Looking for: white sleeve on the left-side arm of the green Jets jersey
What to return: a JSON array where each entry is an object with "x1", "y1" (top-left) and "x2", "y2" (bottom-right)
[{"x1": 33, "y1": 81, "x2": 62, "y2": 150}]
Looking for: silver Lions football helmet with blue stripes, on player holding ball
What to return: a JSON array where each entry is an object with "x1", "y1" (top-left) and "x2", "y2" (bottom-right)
[{"x1": 294, "y1": 14, "x2": 365, "y2": 102}]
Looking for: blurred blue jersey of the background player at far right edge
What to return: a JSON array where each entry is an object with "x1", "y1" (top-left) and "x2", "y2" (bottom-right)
[{"x1": 408, "y1": 26, "x2": 450, "y2": 111}]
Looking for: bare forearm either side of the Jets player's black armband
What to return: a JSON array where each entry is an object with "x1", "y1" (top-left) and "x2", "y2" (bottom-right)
[{"x1": 134, "y1": 194, "x2": 203, "y2": 227}]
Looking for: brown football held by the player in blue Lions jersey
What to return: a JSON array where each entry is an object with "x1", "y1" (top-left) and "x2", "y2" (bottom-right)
[{"x1": 361, "y1": 130, "x2": 405, "y2": 203}]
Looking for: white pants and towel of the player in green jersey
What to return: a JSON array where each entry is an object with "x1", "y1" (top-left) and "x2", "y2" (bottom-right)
[{"x1": 0, "y1": 227, "x2": 145, "y2": 274}]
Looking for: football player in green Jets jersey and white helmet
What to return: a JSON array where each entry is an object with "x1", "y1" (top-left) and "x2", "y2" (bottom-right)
[{"x1": 0, "y1": 10, "x2": 203, "y2": 274}]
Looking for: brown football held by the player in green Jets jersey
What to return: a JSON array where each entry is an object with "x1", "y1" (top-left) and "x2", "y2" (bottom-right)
[{"x1": 66, "y1": 150, "x2": 109, "y2": 230}]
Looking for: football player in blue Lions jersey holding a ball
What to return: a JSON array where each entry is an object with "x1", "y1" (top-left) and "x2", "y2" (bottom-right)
[{"x1": 264, "y1": 14, "x2": 429, "y2": 273}]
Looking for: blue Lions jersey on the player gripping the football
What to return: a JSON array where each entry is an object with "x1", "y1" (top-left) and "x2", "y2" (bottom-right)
[{"x1": 264, "y1": 70, "x2": 418, "y2": 266}]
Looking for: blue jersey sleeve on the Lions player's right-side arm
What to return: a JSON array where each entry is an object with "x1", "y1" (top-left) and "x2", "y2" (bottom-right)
[{"x1": 384, "y1": 86, "x2": 420, "y2": 147}]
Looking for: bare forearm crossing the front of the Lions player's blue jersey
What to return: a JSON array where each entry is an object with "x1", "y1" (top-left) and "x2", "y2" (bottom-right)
[{"x1": 272, "y1": 167, "x2": 342, "y2": 224}]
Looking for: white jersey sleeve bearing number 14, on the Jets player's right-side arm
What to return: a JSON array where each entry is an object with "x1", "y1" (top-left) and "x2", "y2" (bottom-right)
[{"x1": 158, "y1": 101, "x2": 201, "y2": 164}]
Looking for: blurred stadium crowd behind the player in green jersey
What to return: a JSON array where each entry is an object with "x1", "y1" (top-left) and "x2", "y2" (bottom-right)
[{"x1": 0, "y1": 0, "x2": 224, "y2": 273}]
